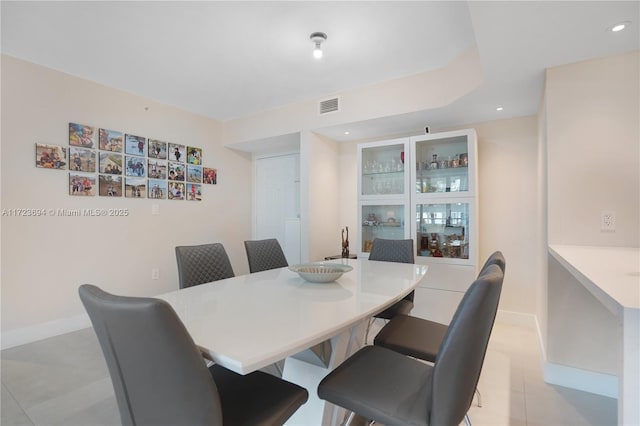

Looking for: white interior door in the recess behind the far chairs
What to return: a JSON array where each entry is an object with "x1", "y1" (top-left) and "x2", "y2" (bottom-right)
[{"x1": 254, "y1": 153, "x2": 300, "y2": 265}]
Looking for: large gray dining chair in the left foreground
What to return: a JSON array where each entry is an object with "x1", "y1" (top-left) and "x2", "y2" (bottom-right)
[{"x1": 79, "y1": 284, "x2": 308, "y2": 426}]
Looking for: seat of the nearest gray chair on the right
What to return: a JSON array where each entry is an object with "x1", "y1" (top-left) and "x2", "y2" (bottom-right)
[{"x1": 318, "y1": 346, "x2": 433, "y2": 425}]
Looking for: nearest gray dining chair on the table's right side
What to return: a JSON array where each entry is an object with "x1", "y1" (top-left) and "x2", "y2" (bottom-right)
[{"x1": 318, "y1": 265, "x2": 504, "y2": 426}]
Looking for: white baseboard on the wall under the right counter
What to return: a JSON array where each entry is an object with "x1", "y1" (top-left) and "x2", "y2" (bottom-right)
[{"x1": 544, "y1": 361, "x2": 618, "y2": 398}]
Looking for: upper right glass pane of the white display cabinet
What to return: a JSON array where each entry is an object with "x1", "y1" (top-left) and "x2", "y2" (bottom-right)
[{"x1": 415, "y1": 135, "x2": 469, "y2": 194}]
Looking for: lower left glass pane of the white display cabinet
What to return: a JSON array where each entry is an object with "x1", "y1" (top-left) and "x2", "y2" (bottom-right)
[{"x1": 360, "y1": 204, "x2": 406, "y2": 253}]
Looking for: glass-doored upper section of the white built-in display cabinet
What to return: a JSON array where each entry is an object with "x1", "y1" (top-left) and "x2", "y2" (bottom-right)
[{"x1": 358, "y1": 129, "x2": 477, "y2": 268}]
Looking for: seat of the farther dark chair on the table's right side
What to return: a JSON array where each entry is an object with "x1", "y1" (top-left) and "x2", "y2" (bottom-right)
[{"x1": 374, "y1": 315, "x2": 449, "y2": 362}]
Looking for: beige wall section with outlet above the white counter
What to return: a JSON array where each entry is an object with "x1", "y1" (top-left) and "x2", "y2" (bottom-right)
[{"x1": 546, "y1": 51, "x2": 640, "y2": 247}]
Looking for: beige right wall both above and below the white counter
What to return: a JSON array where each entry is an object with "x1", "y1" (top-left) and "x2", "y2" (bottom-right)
[{"x1": 545, "y1": 51, "x2": 640, "y2": 386}]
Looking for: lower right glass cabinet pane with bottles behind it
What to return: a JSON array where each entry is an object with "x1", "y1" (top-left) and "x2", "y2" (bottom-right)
[{"x1": 416, "y1": 202, "x2": 469, "y2": 259}]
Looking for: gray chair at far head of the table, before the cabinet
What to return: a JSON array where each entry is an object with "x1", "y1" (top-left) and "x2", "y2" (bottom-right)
[{"x1": 364, "y1": 238, "x2": 415, "y2": 343}]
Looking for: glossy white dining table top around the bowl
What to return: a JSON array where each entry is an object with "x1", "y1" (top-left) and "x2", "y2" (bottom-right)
[{"x1": 158, "y1": 259, "x2": 427, "y2": 374}]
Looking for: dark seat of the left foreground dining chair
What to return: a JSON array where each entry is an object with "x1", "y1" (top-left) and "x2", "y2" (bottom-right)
[{"x1": 209, "y1": 365, "x2": 309, "y2": 426}]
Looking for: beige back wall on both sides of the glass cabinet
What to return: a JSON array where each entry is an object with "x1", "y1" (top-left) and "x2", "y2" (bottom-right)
[{"x1": 340, "y1": 116, "x2": 543, "y2": 315}]
